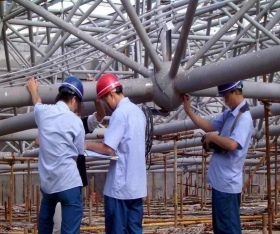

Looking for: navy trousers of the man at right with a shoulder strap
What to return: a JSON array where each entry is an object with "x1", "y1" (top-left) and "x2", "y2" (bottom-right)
[{"x1": 212, "y1": 188, "x2": 241, "y2": 234}]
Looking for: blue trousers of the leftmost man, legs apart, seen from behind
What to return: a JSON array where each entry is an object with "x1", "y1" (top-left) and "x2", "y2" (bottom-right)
[{"x1": 38, "y1": 187, "x2": 83, "y2": 234}]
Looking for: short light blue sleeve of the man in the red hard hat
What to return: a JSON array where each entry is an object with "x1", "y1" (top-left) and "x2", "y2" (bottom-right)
[{"x1": 104, "y1": 115, "x2": 125, "y2": 151}]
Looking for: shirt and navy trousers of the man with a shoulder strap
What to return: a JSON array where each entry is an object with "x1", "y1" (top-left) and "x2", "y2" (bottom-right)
[{"x1": 207, "y1": 100, "x2": 253, "y2": 234}]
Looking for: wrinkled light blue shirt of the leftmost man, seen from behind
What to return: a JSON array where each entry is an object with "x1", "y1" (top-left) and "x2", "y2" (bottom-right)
[{"x1": 34, "y1": 101, "x2": 85, "y2": 194}]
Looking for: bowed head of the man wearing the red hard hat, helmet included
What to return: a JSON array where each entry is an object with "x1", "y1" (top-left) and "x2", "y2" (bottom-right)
[{"x1": 96, "y1": 73, "x2": 123, "y2": 110}]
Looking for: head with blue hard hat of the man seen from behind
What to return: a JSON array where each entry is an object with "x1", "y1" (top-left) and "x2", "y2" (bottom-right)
[{"x1": 56, "y1": 76, "x2": 84, "y2": 112}]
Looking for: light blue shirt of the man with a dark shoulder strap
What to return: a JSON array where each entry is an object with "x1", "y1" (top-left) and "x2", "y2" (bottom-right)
[{"x1": 207, "y1": 100, "x2": 253, "y2": 193}]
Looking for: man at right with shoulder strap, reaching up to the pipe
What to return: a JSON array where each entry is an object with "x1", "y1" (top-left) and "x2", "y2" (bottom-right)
[{"x1": 183, "y1": 81, "x2": 252, "y2": 234}]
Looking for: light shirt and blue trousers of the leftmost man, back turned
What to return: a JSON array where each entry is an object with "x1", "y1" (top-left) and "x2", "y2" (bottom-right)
[{"x1": 34, "y1": 101, "x2": 100, "y2": 234}]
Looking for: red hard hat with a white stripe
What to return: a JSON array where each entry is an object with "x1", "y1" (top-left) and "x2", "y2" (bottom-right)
[{"x1": 96, "y1": 73, "x2": 121, "y2": 98}]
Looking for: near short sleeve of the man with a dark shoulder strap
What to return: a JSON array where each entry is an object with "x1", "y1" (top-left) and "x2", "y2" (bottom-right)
[{"x1": 229, "y1": 116, "x2": 252, "y2": 150}]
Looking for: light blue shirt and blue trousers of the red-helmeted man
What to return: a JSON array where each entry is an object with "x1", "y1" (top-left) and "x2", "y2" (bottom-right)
[{"x1": 104, "y1": 98, "x2": 147, "y2": 234}]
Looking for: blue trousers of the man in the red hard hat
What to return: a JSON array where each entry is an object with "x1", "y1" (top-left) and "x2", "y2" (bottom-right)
[{"x1": 104, "y1": 196, "x2": 143, "y2": 234}]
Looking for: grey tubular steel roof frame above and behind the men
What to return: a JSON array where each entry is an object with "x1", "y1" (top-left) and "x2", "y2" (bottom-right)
[{"x1": 0, "y1": 0, "x2": 280, "y2": 176}]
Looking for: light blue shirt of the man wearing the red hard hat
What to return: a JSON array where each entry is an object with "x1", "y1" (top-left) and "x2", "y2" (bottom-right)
[{"x1": 104, "y1": 98, "x2": 147, "y2": 200}]
